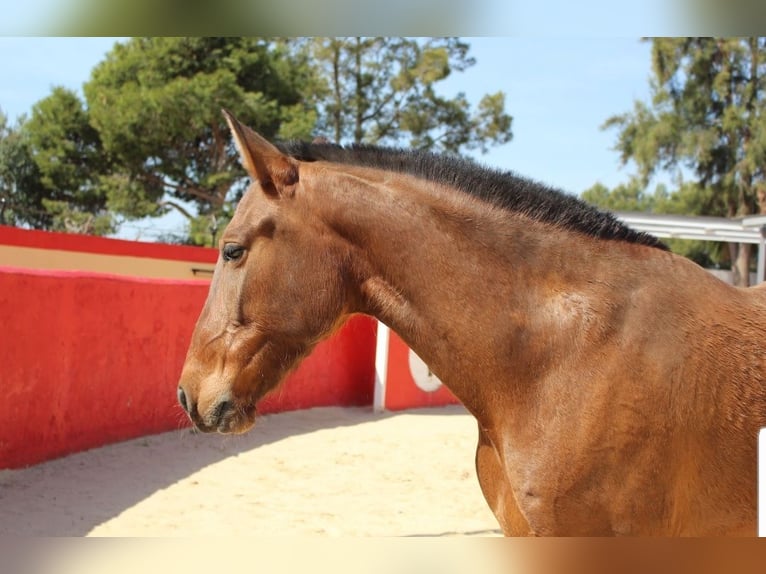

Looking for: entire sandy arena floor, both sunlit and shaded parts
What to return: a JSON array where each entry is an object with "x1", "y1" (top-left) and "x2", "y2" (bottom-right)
[{"x1": 0, "y1": 407, "x2": 499, "y2": 537}]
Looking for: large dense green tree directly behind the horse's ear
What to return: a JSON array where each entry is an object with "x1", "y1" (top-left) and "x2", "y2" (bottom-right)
[{"x1": 84, "y1": 38, "x2": 316, "y2": 244}]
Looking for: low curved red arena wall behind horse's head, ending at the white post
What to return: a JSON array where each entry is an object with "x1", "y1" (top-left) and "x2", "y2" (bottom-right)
[{"x1": 0, "y1": 267, "x2": 375, "y2": 468}]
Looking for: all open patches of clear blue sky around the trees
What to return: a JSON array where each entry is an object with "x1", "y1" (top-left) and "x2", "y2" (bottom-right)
[{"x1": 0, "y1": 37, "x2": 651, "y2": 240}]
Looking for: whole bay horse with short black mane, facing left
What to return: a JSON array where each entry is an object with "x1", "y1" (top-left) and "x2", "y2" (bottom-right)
[{"x1": 178, "y1": 112, "x2": 766, "y2": 536}]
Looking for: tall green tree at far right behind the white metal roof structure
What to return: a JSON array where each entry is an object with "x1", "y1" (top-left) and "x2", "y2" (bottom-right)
[{"x1": 605, "y1": 38, "x2": 766, "y2": 285}]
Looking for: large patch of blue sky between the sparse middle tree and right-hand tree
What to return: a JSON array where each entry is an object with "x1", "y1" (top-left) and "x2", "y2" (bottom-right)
[{"x1": 444, "y1": 37, "x2": 651, "y2": 193}]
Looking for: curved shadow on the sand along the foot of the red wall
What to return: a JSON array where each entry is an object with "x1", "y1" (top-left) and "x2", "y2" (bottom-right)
[{"x1": 0, "y1": 407, "x2": 472, "y2": 536}]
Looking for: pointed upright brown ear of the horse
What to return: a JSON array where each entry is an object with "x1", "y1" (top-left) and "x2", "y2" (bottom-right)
[{"x1": 222, "y1": 110, "x2": 298, "y2": 195}]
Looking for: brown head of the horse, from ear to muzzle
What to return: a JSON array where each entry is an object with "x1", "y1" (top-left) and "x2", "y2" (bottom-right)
[{"x1": 178, "y1": 114, "x2": 356, "y2": 432}]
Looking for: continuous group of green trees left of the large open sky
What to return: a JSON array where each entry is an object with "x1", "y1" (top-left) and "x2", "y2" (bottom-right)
[{"x1": 7, "y1": 37, "x2": 512, "y2": 245}]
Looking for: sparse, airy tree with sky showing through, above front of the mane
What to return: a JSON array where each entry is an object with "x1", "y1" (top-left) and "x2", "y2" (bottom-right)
[{"x1": 304, "y1": 38, "x2": 512, "y2": 153}]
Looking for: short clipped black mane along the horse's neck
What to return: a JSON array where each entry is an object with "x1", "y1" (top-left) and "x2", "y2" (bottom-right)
[{"x1": 278, "y1": 141, "x2": 667, "y2": 250}]
